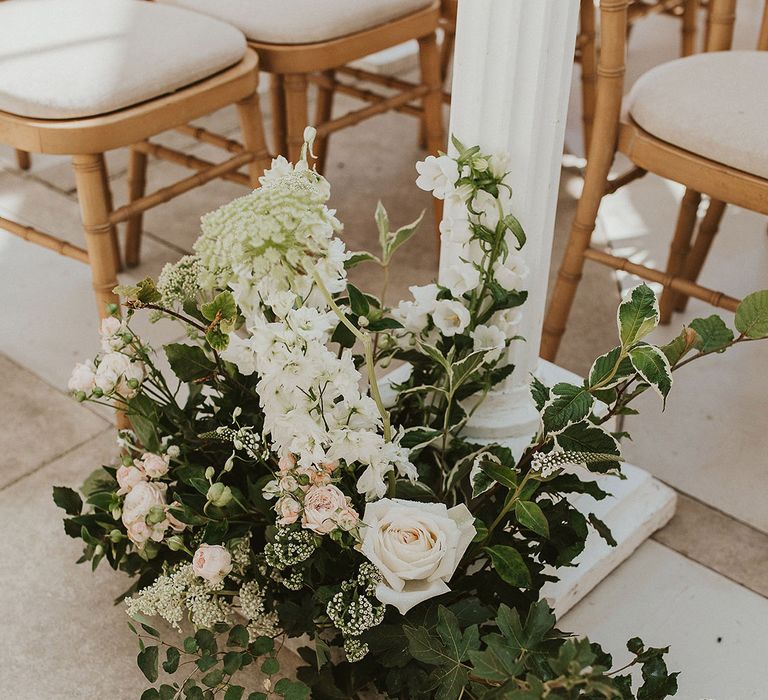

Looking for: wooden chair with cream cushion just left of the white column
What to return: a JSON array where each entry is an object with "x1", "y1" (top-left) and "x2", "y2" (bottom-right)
[{"x1": 159, "y1": 0, "x2": 445, "y2": 172}]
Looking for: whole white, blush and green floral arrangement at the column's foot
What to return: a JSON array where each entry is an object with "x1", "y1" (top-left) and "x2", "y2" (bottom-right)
[{"x1": 54, "y1": 131, "x2": 768, "y2": 700}]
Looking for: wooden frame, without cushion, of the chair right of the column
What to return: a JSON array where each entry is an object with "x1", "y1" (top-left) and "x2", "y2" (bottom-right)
[{"x1": 541, "y1": 0, "x2": 768, "y2": 360}]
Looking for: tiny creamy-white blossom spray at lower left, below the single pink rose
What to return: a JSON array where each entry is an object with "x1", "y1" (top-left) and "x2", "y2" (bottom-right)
[{"x1": 126, "y1": 564, "x2": 231, "y2": 631}]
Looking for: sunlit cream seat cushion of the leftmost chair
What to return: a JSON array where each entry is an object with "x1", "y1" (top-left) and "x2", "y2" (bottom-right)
[{"x1": 0, "y1": 0, "x2": 245, "y2": 119}]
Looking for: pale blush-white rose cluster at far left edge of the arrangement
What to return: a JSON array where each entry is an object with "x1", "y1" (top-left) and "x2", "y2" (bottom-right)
[{"x1": 67, "y1": 317, "x2": 146, "y2": 401}]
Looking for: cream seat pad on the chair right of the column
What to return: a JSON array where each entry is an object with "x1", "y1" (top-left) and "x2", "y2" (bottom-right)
[{"x1": 626, "y1": 51, "x2": 768, "y2": 178}]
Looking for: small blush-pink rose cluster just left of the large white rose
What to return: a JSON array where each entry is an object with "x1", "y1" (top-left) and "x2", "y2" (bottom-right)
[{"x1": 264, "y1": 454, "x2": 360, "y2": 535}]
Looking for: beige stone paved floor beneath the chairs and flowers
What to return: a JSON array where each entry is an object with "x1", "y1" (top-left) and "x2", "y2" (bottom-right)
[{"x1": 0, "y1": 6, "x2": 768, "y2": 700}]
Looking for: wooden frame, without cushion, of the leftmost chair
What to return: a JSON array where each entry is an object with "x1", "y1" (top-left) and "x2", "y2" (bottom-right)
[{"x1": 0, "y1": 50, "x2": 270, "y2": 317}]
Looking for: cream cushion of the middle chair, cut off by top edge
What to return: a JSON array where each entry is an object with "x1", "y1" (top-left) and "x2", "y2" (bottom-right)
[{"x1": 160, "y1": 0, "x2": 433, "y2": 44}]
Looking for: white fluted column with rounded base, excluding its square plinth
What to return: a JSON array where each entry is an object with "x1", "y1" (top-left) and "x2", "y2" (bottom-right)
[{"x1": 440, "y1": 0, "x2": 579, "y2": 445}]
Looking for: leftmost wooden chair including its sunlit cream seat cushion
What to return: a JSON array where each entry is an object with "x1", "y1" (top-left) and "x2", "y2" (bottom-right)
[{"x1": 0, "y1": 0, "x2": 269, "y2": 316}]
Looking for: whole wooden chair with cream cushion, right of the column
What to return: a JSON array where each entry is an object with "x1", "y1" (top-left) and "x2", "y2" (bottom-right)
[{"x1": 541, "y1": 0, "x2": 768, "y2": 360}]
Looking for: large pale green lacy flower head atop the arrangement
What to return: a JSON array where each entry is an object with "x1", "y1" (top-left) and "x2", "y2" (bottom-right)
[{"x1": 195, "y1": 157, "x2": 346, "y2": 316}]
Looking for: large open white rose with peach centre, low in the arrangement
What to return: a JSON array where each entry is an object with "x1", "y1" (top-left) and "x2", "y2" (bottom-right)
[{"x1": 361, "y1": 498, "x2": 476, "y2": 615}]
